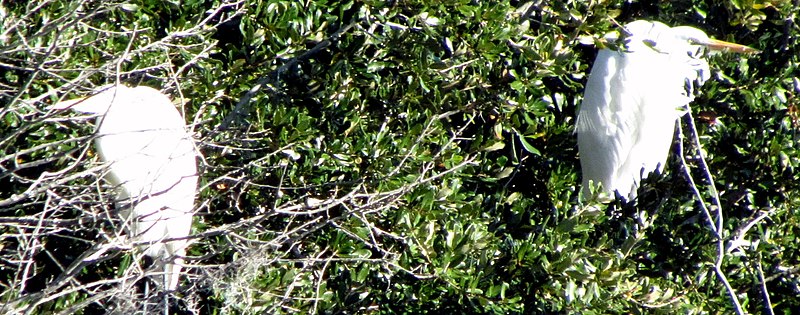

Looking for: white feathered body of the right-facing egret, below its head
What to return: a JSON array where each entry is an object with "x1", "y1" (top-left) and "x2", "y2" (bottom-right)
[{"x1": 576, "y1": 50, "x2": 682, "y2": 199}]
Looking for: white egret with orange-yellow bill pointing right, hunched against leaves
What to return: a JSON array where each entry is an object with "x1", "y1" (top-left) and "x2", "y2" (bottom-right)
[{"x1": 575, "y1": 20, "x2": 757, "y2": 201}]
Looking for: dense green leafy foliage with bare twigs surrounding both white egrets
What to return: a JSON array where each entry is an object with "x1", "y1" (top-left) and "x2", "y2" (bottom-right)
[{"x1": 0, "y1": 0, "x2": 800, "y2": 314}]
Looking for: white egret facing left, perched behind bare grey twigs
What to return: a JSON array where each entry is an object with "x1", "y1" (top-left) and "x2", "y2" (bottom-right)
[{"x1": 52, "y1": 85, "x2": 197, "y2": 290}]
